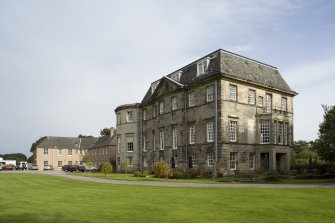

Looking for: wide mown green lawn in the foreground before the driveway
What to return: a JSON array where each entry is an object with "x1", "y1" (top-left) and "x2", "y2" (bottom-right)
[{"x1": 0, "y1": 174, "x2": 335, "y2": 223}]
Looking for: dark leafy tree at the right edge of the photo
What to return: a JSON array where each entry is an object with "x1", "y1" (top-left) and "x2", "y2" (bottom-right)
[{"x1": 314, "y1": 105, "x2": 335, "y2": 162}]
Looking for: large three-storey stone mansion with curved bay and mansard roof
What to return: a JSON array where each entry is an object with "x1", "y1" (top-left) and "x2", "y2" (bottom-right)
[{"x1": 115, "y1": 49, "x2": 297, "y2": 175}]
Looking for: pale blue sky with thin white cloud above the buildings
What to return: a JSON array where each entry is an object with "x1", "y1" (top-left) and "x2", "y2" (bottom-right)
[{"x1": 0, "y1": 0, "x2": 335, "y2": 156}]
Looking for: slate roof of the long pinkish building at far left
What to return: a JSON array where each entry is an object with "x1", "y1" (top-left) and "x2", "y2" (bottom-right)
[{"x1": 37, "y1": 136, "x2": 97, "y2": 149}]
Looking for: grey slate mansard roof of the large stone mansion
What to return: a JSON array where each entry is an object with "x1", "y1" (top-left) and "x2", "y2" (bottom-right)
[{"x1": 141, "y1": 49, "x2": 297, "y2": 104}]
